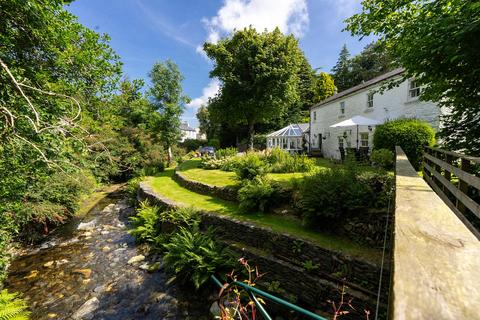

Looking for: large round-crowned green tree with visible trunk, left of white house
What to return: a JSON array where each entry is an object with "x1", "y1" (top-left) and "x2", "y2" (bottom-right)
[{"x1": 204, "y1": 27, "x2": 303, "y2": 148}]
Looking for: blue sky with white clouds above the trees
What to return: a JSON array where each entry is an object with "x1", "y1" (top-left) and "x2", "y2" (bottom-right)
[{"x1": 66, "y1": 0, "x2": 371, "y2": 127}]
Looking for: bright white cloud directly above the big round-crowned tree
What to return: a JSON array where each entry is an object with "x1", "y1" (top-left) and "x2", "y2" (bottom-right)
[{"x1": 197, "y1": 0, "x2": 308, "y2": 48}]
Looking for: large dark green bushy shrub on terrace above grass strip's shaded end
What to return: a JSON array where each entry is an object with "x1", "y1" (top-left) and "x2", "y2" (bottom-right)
[{"x1": 297, "y1": 168, "x2": 375, "y2": 225}]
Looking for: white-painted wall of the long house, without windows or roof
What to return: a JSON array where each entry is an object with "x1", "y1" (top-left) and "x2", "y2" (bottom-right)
[{"x1": 310, "y1": 77, "x2": 441, "y2": 159}]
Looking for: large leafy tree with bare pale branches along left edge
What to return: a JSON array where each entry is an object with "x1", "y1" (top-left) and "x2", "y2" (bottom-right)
[{"x1": 0, "y1": 0, "x2": 121, "y2": 216}]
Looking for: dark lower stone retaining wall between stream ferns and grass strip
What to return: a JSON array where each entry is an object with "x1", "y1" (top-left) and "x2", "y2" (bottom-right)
[{"x1": 137, "y1": 182, "x2": 389, "y2": 319}]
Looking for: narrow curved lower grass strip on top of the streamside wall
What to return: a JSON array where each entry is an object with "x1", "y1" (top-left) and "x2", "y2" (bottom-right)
[{"x1": 147, "y1": 169, "x2": 380, "y2": 262}]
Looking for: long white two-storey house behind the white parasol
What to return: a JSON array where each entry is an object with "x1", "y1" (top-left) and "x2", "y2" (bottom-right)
[{"x1": 310, "y1": 69, "x2": 441, "y2": 159}]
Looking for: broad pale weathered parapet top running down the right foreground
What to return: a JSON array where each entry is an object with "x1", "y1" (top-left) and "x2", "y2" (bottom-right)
[{"x1": 390, "y1": 147, "x2": 480, "y2": 320}]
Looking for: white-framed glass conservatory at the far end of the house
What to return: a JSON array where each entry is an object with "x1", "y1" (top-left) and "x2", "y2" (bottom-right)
[{"x1": 267, "y1": 123, "x2": 309, "y2": 152}]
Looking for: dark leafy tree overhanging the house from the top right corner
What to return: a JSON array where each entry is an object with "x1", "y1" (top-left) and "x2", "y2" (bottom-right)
[{"x1": 346, "y1": 0, "x2": 480, "y2": 156}]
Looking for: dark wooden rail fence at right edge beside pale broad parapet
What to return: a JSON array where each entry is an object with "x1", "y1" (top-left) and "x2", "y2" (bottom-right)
[{"x1": 423, "y1": 147, "x2": 480, "y2": 236}]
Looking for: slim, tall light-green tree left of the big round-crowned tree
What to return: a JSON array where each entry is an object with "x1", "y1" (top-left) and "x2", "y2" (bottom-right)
[{"x1": 148, "y1": 60, "x2": 189, "y2": 164}]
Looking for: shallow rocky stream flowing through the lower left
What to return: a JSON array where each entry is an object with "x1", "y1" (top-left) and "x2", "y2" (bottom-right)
[{"x1": 6, "y1": 192, "x2": 210, "y2": 319}]
